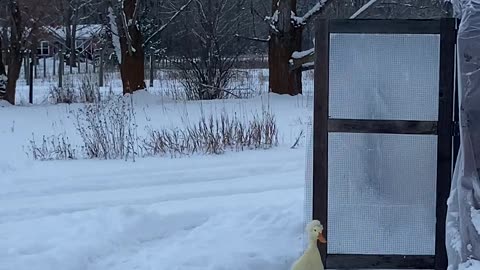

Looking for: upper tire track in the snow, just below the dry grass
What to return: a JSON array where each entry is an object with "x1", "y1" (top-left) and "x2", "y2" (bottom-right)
[{"x1": 0, "y1": 159, "x2": 304, "y2": 199}]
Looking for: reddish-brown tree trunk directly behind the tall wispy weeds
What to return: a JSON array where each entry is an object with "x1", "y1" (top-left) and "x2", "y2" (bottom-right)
[{"x1": 117, "y1": 0, "x2": 146, "y2": 94}]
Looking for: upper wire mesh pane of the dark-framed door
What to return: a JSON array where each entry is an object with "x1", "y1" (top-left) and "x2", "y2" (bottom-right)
[{"x1": 329, "y1": 33, "x2": 440, "y2": 121}]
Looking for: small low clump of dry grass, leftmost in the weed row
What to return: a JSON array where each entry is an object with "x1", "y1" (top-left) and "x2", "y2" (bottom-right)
[{"x1": 27, "y1": 134, "x2": 76, "y2": 160}]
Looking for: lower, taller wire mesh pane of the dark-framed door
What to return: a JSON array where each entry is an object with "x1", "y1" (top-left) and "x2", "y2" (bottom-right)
[{"x1": 327, "y1": 133, "x2": 437, "y2": 255}]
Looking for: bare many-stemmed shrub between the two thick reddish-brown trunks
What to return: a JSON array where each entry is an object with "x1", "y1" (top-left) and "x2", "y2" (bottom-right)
[{"x1": 175, "y1": 0, "x2": 250, "y2": 99}]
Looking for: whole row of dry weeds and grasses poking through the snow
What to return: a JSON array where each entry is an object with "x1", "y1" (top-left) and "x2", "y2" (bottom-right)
[{"x1": 25, "y1": 96, "x2": 278, "y2": 160}]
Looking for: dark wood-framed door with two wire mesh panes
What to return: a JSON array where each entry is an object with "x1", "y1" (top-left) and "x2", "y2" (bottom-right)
[{"x1": 312, "y1": 19, "x2": 455, "y2": 269}]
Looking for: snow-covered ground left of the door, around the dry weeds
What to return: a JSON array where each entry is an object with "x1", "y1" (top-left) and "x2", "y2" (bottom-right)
[{"x1": 0, "y1": 70, "x2": 313, "y2": 270}]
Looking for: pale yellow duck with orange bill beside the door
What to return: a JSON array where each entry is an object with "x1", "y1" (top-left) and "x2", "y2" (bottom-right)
[{"x1": 291, "y1": 220, "x2": 327, "y2": 270}]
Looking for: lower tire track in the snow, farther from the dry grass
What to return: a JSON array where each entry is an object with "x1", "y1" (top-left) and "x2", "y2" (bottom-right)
[{"x1": 0, "y1": 171, "x2": 303, "y2": 224}]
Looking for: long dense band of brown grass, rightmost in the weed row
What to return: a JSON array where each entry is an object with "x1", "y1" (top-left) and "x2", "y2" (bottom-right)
[{"x1": 141, "y1": 109, "x2": 278, "y2": 156}]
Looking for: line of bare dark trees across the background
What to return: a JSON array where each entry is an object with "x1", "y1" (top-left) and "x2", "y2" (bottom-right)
[{"x1": 0, "y1": 0, "x2": 450, "y2": 104}]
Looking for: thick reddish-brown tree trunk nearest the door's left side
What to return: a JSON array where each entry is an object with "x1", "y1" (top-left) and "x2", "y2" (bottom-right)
[{"x1": 268, "y1": 0, "x2": 302, "y2": 95}]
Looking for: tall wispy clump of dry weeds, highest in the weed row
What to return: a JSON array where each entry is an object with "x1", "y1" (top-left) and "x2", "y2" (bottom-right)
[{"x1": 75, "y1": 96, "x2": 137, "y2": 159}]
